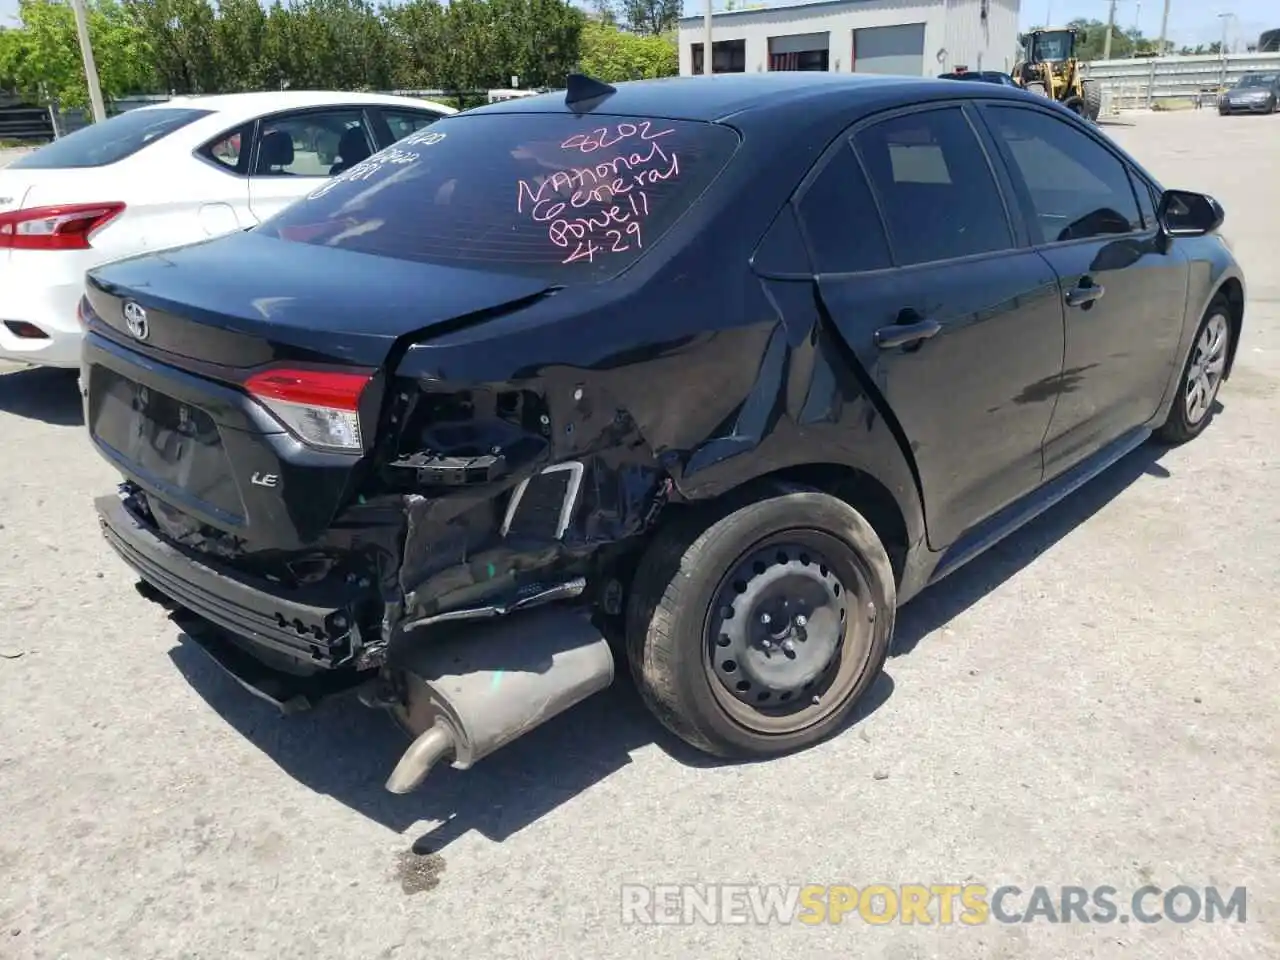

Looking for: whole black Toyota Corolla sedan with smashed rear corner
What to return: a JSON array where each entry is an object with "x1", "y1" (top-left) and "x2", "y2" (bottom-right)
[{"x1": 82, "y1": 73, "x2": 1245, "y2": 791}]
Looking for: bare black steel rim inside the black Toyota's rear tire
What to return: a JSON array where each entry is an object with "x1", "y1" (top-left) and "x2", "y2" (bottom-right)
[{"x1": 703, "y1": 530, "x2": 876, "y2": 736}]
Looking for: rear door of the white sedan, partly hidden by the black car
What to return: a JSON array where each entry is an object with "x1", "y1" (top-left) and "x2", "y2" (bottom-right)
[{"x1": 248, "y1": 106, "x2": 378, "y2": 220}]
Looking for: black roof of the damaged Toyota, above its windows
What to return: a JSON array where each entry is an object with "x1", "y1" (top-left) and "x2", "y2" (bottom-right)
[{"x1": 455, "y1": 70, "x2": 1021, "y2": 122}]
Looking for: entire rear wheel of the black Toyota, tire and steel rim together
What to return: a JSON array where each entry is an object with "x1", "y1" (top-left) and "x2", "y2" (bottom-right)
[{"x1": 627, "y1": 490, "x2": 897, "y2": 758}]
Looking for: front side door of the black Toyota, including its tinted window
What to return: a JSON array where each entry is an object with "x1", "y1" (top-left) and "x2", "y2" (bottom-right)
[{"x1": 983, "y1": 104, "x2": 1189, "y2": 475}]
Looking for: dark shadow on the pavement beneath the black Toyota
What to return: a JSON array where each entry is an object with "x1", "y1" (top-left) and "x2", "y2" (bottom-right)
[{"x1": 170, "y1": 432, "x2": 1169, "y2": 854}]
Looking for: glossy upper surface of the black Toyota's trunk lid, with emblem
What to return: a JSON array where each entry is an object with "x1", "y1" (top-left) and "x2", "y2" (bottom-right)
[{"x1": 87, "y1": 232, "x2": 552, "y2": 369}]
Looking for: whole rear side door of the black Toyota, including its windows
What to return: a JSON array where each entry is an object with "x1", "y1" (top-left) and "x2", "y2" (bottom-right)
[{"x1": 797, "y1": 105, "x2": 1064, "y2": 548}]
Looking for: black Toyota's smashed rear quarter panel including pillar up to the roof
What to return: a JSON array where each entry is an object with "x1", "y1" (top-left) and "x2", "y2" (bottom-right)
[{"x1": 373, "y1": 114, "x2": 923, "y2": 632}]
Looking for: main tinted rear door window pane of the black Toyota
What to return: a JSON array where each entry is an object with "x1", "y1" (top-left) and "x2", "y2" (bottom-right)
[{"x1": 854, "y1": 106, "x2": 1014, "y2": 266}]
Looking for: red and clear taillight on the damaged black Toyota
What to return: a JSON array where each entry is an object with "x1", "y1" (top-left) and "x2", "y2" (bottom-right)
[{"x1": 244, "y1": 369, "x2": 370, "y2": 452}]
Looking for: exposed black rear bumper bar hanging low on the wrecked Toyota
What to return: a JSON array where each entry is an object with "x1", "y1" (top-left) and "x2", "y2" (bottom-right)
[{"x1": 93, "y1": 494, "x2": 355, "y2": 672}]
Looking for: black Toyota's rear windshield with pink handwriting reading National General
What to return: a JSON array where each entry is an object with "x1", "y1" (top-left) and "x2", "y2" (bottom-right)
[{"x1": 256, "y1": 114, "x2": 737, "y2": 284}]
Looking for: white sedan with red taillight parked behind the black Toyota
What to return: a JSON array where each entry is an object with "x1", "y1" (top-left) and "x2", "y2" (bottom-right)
[{"x1": 0, "y1": 91, "x2": 456, "y2": 367}]
